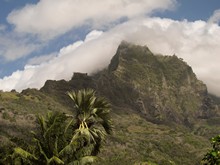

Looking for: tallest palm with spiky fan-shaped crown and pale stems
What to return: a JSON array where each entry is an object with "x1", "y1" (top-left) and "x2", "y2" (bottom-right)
[{"x1": 67, "y1": 89, "x2": 113, "y2": 155}]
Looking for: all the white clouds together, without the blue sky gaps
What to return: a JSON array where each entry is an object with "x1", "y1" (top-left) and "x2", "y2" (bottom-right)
[{"x1": 0, "y1": 0, "x2": 220, "y2": 96}]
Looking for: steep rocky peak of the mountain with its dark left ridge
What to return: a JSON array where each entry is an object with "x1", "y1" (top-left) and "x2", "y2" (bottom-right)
[{"x1": 42, "y1": 42, "x2": 216, "y2": 126}]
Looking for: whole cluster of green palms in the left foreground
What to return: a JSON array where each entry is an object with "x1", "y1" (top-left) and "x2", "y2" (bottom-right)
[{"x1": 5, "y1": 90, "x2": 112, "y2": 164}]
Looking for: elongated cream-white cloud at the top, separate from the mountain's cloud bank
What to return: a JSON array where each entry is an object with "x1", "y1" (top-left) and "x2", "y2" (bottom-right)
[{"x1": 7, "y1": 0, "x2": 176, "y2": 40}]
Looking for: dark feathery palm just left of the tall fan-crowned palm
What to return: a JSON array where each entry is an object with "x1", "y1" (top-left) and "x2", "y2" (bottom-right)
[{"x1": 14, "y1": 112, "x2": 69, "y2": 164}]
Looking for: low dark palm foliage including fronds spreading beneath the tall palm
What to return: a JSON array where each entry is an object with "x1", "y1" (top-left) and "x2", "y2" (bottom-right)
[{"x1": 11, "y1": 112, "x2": 96, "y2": 165}]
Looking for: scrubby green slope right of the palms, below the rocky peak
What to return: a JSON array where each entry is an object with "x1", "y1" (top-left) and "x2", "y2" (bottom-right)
[{"x1": 97, "y1": 107, "x2": 209, "y2": 165}]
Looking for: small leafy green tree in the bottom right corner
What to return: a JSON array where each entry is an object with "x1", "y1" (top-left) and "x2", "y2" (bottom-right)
[{"x1": 202, "y1": 135, "x2": 220, "y2": 165}]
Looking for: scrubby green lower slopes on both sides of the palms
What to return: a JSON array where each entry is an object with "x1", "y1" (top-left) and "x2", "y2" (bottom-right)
[{"x1": 0, "y1": 85, "x2": 218, "y2": 165}]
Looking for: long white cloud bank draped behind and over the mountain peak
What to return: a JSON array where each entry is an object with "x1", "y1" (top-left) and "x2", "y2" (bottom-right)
[{"x1": 0, "y1": 18, "x2": 220, "y2": 96}]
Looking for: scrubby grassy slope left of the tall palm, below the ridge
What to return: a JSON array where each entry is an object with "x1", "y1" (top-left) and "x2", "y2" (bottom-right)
[{"x1": 0, "y1": 89, "x2": 68, "y2": 155}]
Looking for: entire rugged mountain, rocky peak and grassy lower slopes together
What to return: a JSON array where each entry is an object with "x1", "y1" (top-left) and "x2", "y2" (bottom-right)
[{"x1": 0, "y1": 41, "x2": 220, "y2": 164}]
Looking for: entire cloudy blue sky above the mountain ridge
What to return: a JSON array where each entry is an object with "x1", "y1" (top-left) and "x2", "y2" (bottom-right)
[{"x1": 0, "y1": 0, "x2": 220, "y2": 96}]
